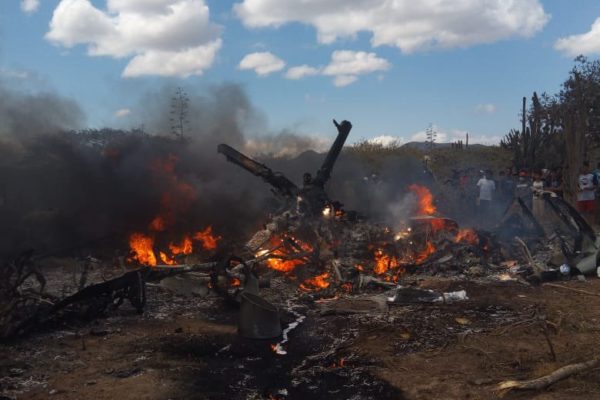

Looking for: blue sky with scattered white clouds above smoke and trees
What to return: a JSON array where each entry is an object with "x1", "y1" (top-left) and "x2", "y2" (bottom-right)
[{"x1": 0, "y1": 0, "x2": 600, "y2": 143}]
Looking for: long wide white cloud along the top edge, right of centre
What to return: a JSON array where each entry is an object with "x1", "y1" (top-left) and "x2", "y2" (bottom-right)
[{"x1": 234, "y1": 0, "x2": 550, "y2": 53}]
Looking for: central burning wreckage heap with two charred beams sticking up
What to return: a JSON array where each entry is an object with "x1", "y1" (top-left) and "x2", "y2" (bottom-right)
[{"x1": 219, "y1": 121, "x2": 499, "y2": 302}]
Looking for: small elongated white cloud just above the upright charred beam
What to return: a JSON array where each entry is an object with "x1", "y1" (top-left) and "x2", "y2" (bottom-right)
[{"x1": 285, "y1": 50, "x2": 391, "y2": 87}]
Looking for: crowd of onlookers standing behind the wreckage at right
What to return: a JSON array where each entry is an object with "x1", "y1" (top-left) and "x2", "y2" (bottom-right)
[{"x1": 457, "y1": 161, "x2": 600, "y2": 225}]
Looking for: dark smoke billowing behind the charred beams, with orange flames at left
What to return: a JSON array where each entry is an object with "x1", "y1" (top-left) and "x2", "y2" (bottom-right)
[{"x1": 0, "y1": 83, "x2": 432, "y2": 265}]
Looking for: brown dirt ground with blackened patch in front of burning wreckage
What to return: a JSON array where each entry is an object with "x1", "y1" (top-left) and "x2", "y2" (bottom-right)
[{"x1": 0, "y1": 278, "x2": 600, "y2": 400}]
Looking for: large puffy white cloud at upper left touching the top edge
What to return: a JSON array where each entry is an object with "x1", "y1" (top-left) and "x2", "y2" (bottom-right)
[{"x1": 46, "y1": 0, "x2": 222, "y2": 77}]
